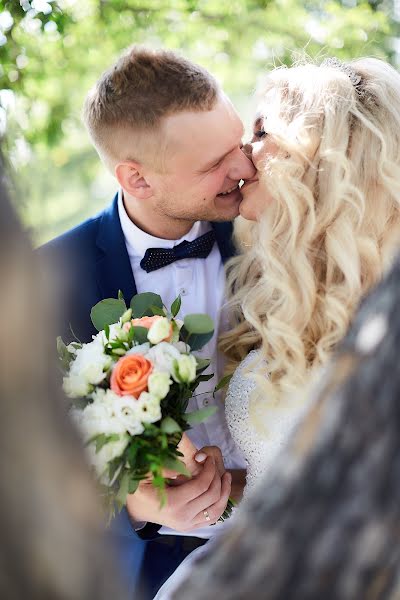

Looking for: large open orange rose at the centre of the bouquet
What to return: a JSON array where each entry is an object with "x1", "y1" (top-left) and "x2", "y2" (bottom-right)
[{"x1": 110, "y1": 354, "x2": 153, "y2": 398}]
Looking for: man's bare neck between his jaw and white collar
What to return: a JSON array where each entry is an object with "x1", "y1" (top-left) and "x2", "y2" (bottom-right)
[{"x1": 122, "y1": 194, "x2": 194, "y2": 240}]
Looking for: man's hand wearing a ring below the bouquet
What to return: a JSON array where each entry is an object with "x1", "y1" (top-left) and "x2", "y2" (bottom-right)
[{"x1": 127, "y1": 458, "x2": 232, "y2": 531}]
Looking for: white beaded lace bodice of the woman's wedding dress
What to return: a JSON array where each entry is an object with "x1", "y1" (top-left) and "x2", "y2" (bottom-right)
[{"x1": 225, "y1": 350, "x2": 307, "y2": 495}]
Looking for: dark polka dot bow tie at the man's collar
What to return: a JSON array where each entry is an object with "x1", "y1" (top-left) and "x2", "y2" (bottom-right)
[{"x1": 140, "y1": 231, "x2": 215, "y2": 273}]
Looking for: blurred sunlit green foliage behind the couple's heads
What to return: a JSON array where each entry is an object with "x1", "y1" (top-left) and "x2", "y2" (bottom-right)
[{"x1": 0, "y1": 0, "x2": 399, "y2": 241}]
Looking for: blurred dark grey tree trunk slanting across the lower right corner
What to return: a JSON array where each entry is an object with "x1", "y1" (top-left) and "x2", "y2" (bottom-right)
[{"x1": 174, "y1": 255, "x2": 400, "y2": 600}]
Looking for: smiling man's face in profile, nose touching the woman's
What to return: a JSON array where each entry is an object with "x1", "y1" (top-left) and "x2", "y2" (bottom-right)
[{"x1": 147, "y1": 96, "x2": 255, "y2": 222}]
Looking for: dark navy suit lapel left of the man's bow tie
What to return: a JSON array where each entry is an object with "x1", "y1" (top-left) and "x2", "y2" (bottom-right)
[{"x1": 96, "y1": 195, "x2": 137, "y2": 304}]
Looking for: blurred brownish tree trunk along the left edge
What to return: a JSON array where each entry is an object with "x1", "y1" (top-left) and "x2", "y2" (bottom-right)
[{"x1": 0, "y1": 160, "x2": 124, "y2": 600}]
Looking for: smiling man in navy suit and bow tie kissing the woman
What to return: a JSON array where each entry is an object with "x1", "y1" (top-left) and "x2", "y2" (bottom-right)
[{"x1": 40, "y1": 47, "x2": 254, "y2": 596}]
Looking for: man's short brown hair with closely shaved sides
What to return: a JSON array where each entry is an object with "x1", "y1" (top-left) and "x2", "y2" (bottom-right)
[{"x1": 83, "y1": 46, "x2": 219, "y2": 169}]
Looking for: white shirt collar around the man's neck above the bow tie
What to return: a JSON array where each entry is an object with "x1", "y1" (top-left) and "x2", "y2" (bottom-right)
[{"x1": 118, "y1": 189, "x2": 211, "y2": 258}]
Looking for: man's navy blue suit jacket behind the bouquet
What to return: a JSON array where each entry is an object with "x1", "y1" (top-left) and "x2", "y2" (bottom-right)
[{"x1": 38, "y1": 195, "x2": 234, "y2": 588}]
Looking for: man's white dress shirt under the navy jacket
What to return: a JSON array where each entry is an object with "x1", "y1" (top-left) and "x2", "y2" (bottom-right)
[{"x1": 118, "y1": 190, "x2": 246, "y2": 538}]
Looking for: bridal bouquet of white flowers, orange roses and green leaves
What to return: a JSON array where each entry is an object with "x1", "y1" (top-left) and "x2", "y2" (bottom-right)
[{"x1": 57, "y1": 292, "x2": 232, "y2": 518}]
